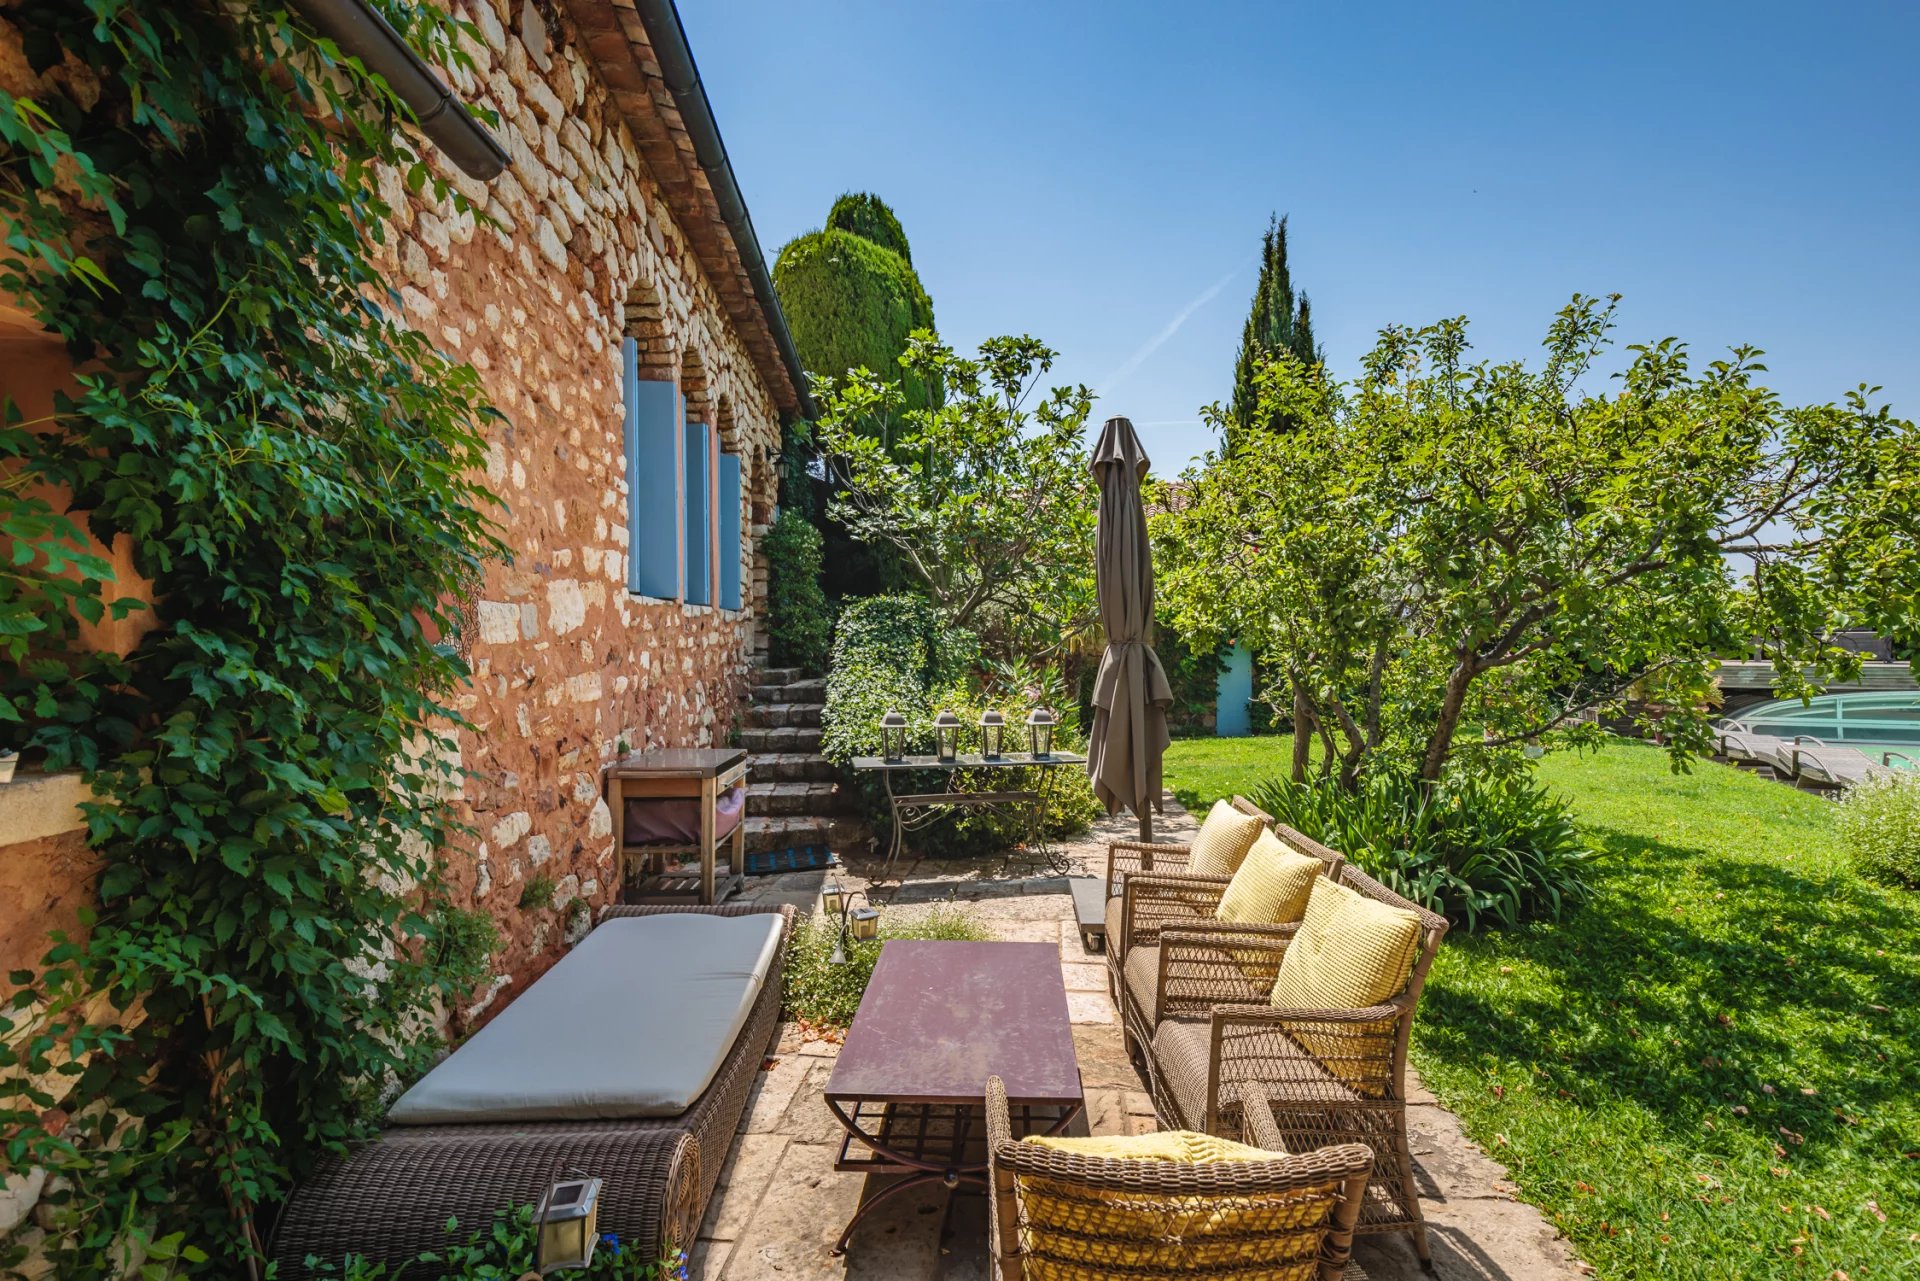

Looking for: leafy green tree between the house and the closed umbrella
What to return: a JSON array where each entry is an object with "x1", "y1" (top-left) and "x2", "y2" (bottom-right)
[{"x1": 818, "y1": 332, "x2": 1094, "y2": 651}]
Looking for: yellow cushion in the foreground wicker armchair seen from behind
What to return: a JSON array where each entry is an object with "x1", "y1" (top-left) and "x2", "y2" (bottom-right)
[{"x1": 1016, "y1": 1129, "x2": 1338, "y2": 1281}]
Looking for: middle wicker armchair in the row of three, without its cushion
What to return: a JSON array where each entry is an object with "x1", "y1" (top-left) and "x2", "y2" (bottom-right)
[{"x1": 1106, "y1": 825, "x2": 1346, "y2": 1052}]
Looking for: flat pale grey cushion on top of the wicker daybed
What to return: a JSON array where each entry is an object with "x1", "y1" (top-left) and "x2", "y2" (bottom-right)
[{"x1": 388, "y1": 912, "x2": 780, "y2": 1125}]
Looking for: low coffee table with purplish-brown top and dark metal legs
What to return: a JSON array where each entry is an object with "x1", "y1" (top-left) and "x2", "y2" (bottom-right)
[{"x1": 826, "y1": 939, "x2": 1085, "y2": 1254}]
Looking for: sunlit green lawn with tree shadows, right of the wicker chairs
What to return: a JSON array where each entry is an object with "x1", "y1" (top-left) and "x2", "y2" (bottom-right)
[{"x1": 1167, "y1": 737, "x2": 1920, "y2": 1281}]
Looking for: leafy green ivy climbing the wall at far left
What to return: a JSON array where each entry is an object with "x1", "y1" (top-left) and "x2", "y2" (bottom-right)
[{"x1": 0, "y1": 0, "x2": 503, "y2": 1277}]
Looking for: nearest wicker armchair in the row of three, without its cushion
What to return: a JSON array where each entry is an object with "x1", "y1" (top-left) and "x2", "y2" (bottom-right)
[{"x1": 1148, "y1": 864, "x2": 1448, "y2": 1262}]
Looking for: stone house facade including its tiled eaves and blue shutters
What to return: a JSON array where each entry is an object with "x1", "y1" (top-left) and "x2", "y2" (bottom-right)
[{"x1": 0, "y1": 0, "x2": 806, "y2": 1024}]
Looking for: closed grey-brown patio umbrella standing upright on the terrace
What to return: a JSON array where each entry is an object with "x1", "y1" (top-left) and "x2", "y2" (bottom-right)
[{"x1": 1087, "y1": 419, "x2": 1173, "y2": 839}]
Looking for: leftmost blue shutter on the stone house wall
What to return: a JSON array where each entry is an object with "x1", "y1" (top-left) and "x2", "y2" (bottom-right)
[{"x1": 620, "y1": 338, "x2": 685, "y2": 599}]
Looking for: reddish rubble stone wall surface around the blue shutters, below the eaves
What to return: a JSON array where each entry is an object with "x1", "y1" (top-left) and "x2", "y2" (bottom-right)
[{"x1": 386, "y1": 0, "x2": 780, "y2": 1018}]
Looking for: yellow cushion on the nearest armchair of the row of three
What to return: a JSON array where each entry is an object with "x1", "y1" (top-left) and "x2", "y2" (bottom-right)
[{"x1": 1271, "y1": 878, "x2": 1421, "y2": 1099}]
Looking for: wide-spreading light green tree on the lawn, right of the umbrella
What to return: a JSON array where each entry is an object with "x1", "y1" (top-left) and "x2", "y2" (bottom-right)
[{"x1": 1156, "y1": 296, "x2": 1920, "y2": 787}]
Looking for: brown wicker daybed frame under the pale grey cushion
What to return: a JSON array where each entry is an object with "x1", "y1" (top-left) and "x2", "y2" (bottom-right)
[{"x1": 271, "y1": 905, "x2": 795, "y2": 1277}]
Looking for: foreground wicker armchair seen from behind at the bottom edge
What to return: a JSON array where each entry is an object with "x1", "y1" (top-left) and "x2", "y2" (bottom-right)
[{"x1": 987, "y1": 1077, "x2": 1373, "y2": 1281}]
